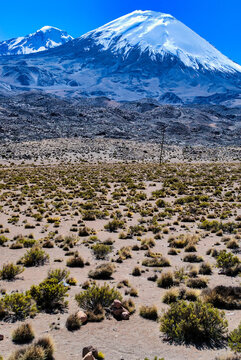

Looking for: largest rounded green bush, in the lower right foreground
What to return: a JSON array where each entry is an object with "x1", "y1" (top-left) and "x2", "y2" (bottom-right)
[{"x1": 160, "y1": 300, "x2": 228, "y2": 346}]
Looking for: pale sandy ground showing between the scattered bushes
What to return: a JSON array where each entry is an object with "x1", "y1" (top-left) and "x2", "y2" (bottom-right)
[{"x1": 0, "y1": 165, "x2": 241, "y2": 360}]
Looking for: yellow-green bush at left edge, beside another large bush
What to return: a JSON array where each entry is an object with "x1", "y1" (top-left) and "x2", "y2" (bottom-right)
[{"x1": 0, "y1": 292, "x2": 37, "y2": 321}]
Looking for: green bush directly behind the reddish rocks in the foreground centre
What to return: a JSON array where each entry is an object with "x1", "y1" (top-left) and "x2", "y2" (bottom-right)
[{"x1": 75, "y1": 284, "x2": 122, "y2": 311}]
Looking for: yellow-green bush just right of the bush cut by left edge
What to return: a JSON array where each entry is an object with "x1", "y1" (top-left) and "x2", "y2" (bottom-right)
[{"x1": 29, "y1": 278, "x2": 68, "y2": 312}]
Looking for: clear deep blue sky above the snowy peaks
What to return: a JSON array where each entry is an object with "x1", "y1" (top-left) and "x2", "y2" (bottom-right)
[{"x1": 0, "y1": 0, "x2": 241, "y2": 64}]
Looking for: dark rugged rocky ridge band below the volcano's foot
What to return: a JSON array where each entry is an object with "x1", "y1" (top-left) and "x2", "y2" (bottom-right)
[{"x1": 0, "y1": 92, "x2": 241, "y2": 146}]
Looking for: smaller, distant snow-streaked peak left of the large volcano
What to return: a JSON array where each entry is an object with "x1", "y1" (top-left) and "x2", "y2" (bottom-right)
[{"x1": 0, "y1": 26, "x2": 73, "y2": 55}]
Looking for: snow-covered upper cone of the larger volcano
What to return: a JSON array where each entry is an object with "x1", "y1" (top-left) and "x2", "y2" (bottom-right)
[{"x1": 80, "y1": 10, "x2": 241, "y2": 72}]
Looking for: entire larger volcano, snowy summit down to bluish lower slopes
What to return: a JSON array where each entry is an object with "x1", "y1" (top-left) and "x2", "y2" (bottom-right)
[{"x1": 0, "y1": 11, "x2": 241, "y2": 103}]
